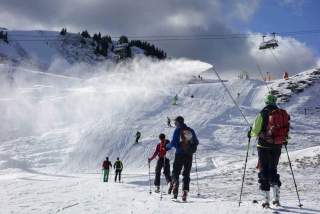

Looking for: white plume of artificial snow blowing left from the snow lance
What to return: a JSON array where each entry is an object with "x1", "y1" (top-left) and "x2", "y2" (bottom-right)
[{"x1": 0, "y1": 58, "x2": 210, "y2": 171}]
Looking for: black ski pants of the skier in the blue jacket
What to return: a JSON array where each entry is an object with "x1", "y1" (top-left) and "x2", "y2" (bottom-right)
[{"x1": 172, "y1": 154, "x2": 192, "y2": 194}]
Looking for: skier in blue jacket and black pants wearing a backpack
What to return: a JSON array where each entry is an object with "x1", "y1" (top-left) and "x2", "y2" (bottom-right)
[{"x1": 166, "y1": 116, "x2": 199, "y2": 201}]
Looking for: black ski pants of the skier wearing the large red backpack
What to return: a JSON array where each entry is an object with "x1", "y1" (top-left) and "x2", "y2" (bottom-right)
[{"x1": 258, "y1": 147, "x2": 281, "y2": 191}]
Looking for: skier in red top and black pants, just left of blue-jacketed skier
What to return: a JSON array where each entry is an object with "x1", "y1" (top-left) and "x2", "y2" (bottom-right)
[{"x1": 148, "y1": 133, "x2": 173, "y2": 194}]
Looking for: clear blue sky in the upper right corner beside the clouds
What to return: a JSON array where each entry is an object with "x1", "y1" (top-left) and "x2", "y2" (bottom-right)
[{"x1": 236, "y1": 0, "x2": 320, "y2": 56}]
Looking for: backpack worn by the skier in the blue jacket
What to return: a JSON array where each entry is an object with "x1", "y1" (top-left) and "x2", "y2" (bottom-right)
[{"x1": 180, "y1": 127, "x2": 199, "y2": 155}]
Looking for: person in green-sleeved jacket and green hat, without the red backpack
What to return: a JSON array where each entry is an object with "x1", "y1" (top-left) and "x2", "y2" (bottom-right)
[{"x1": 248, "y1": 94, "x2": 288, "y2": 207}]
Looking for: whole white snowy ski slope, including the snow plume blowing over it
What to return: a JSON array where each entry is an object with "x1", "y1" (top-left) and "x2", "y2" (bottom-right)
[{"x1": 0, "y1": 59, "x2": 320, "y2": 214}]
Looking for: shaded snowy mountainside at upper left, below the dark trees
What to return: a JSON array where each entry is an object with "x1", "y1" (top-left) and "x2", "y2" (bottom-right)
[{"x1": 0, "y1": 28, "x2": 158, "y2": 69}]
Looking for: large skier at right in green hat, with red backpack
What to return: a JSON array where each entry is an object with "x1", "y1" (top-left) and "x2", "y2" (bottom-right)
[{"x1": 248, "y1": 94, "x2": 290, "y2": 208}]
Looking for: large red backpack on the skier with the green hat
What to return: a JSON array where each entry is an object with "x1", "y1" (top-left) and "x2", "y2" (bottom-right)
[{"x1": 266, "y1": 109, "x2": 290, "y2": 144}]
